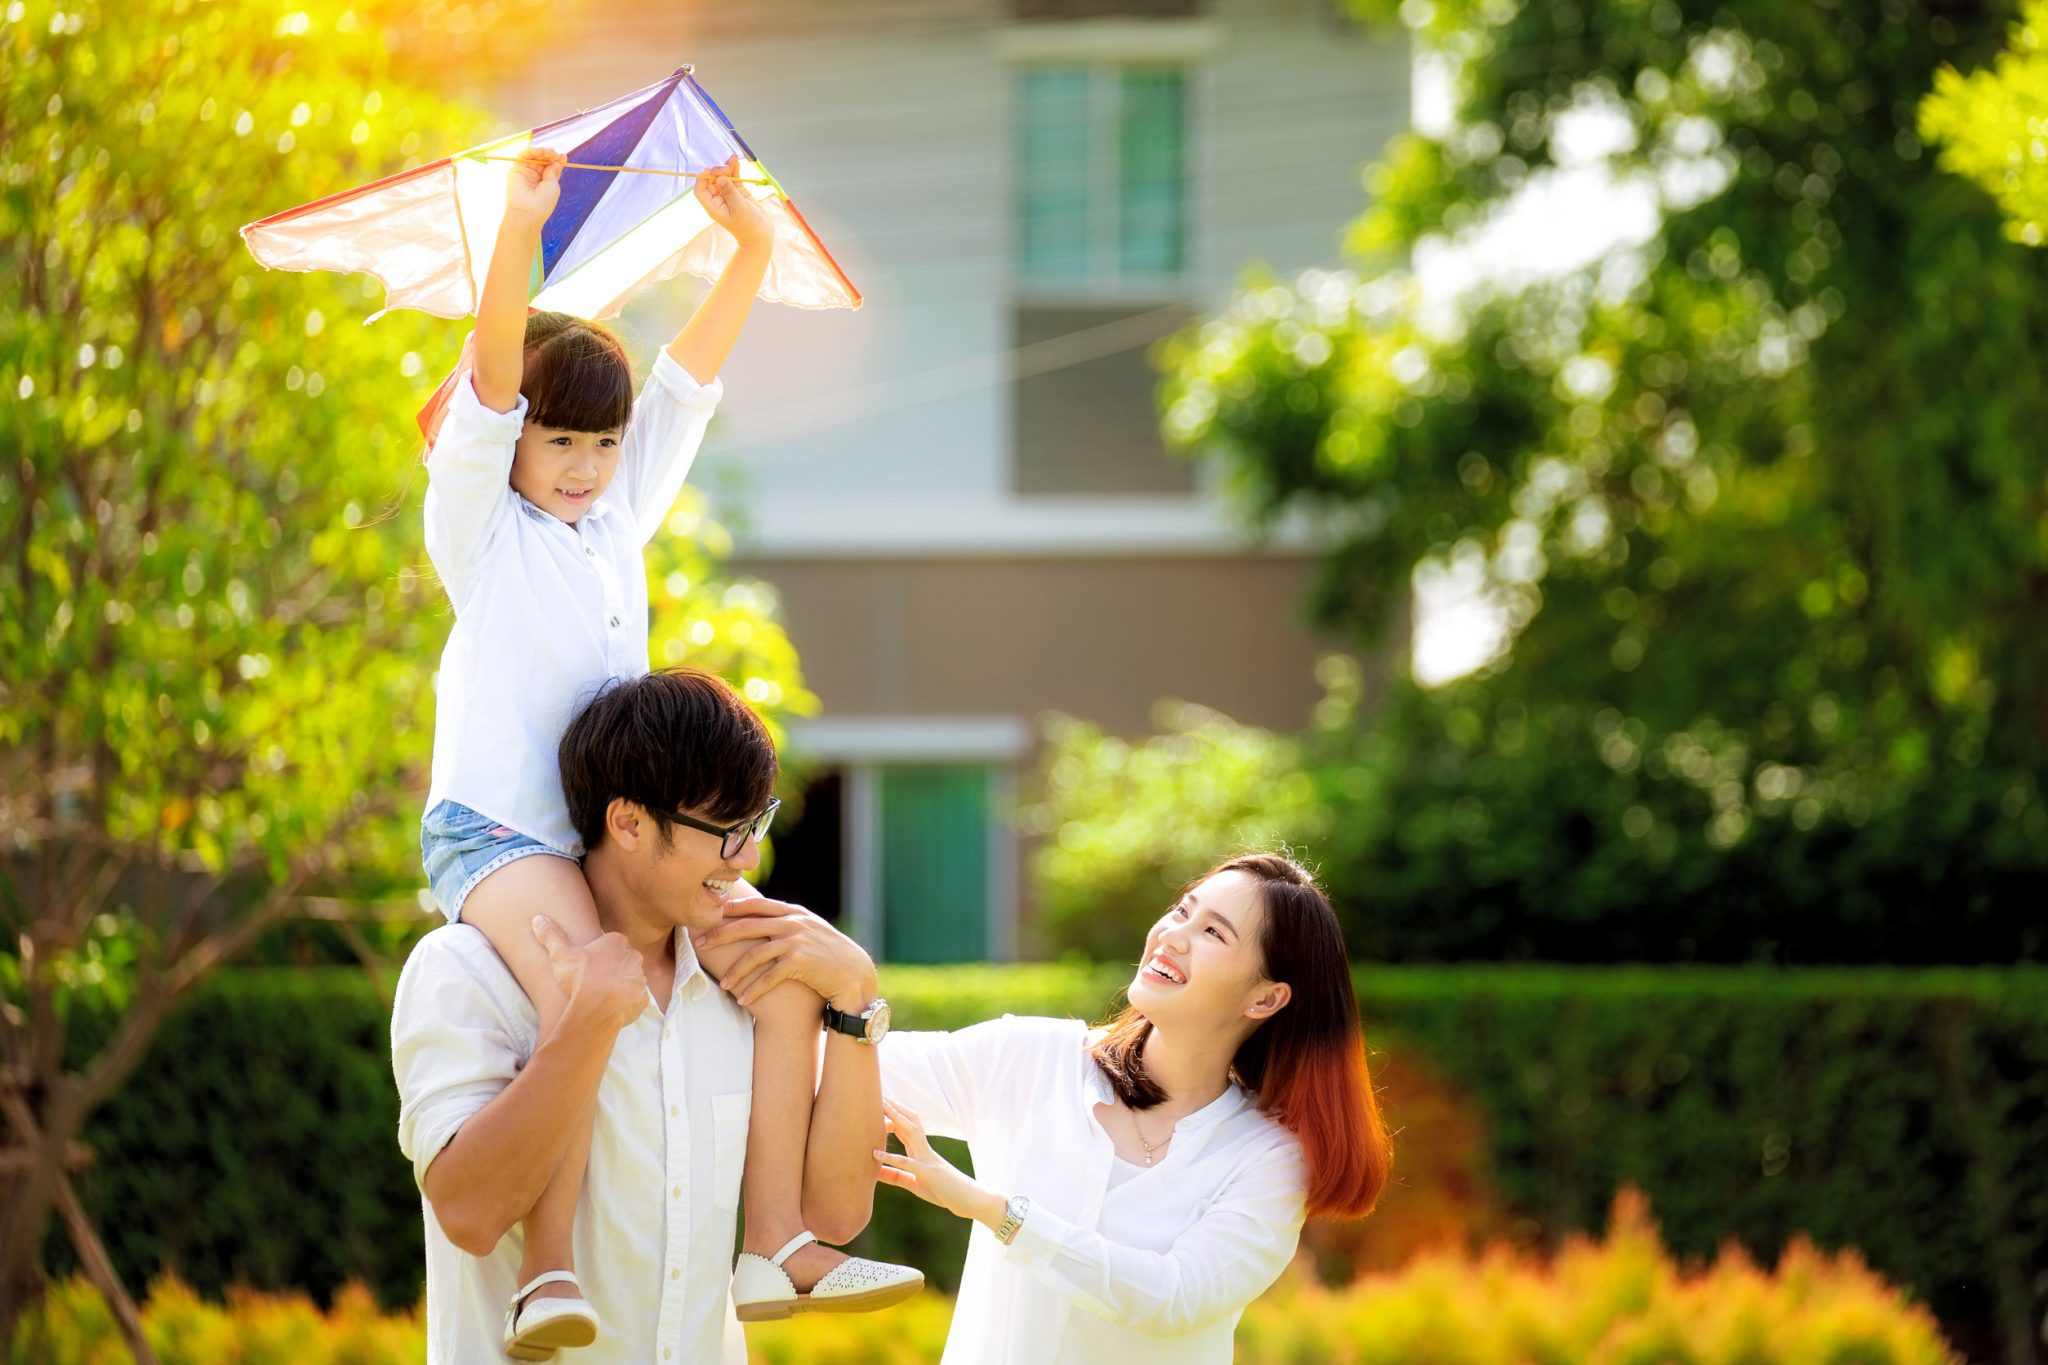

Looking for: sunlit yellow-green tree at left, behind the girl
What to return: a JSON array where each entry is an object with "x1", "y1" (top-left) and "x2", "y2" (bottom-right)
[{"x1": 0, "y1": 0, "x2": 811, "y2": 1330}]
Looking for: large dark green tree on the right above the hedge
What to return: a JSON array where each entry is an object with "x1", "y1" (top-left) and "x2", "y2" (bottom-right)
[{"x1": 1165, "y1": 0, "x2": 2048, "y2": 960}]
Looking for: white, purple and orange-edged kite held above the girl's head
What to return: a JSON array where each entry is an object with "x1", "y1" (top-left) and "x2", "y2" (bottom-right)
[{"x1": 242, "y1": 65, "x2": 860, "y2": 440}]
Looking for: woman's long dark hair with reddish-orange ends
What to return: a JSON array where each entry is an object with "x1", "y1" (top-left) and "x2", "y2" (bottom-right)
[{"x1": 1094, "y1": 853, "x2": 1393, "y2": 1218}]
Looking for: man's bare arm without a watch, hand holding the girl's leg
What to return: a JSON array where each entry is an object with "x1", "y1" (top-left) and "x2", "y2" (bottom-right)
[{"x1": 420, "y1": 919, "x2": 647, "y2": 1257}]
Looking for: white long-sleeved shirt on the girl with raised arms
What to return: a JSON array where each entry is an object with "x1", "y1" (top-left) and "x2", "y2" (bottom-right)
[{"x1": 426, "y1": 350, "x2": 723, "y2": 857}]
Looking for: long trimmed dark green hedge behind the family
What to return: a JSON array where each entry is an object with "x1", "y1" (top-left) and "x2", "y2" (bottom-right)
[{"x1": 55, "y1": 966, "x2": 2048, "y2": 1349}]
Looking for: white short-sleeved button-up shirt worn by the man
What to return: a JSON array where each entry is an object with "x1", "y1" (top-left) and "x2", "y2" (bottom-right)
[{"x1": 391, "y1": 925, "x2": 754, "y2": 1365}]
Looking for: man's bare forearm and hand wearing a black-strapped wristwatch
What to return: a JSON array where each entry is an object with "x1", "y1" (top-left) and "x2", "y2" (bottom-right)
[{"x1": 692, "y1": 896, "x2": 887, "y2": 1242}]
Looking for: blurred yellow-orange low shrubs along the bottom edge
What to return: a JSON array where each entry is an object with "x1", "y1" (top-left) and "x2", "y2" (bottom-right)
[{"x1": 14, "y1": 1191, "x2": 1962, "y2": 1365}]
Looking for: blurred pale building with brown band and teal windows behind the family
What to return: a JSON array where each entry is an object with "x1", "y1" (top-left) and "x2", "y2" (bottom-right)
[{"x1": 500, "y1": 0, "x2": 1409, "y2": 960}]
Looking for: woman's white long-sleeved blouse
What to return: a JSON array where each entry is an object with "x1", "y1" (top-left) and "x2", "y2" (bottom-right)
[{"x1": 881, "y1": 1015, "x2": 1307, "y2": 1365}]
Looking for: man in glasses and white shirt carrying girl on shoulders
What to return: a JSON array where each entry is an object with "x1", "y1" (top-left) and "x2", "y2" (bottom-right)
[{"x1": 391, "y1": 669, "x2": 885, "y2": 1365}]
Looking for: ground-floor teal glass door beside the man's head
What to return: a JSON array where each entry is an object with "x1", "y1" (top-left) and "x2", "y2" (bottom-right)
[{"x1": 881, "y1": 763, "x2": 989, "y2": 962}]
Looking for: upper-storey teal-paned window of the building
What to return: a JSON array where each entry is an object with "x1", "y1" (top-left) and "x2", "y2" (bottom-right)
[{"x1": 1016, "y1": 63, "x2": 1188, "y2": 291}]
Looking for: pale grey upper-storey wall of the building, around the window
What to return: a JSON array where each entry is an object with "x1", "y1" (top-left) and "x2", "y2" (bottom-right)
[{"x1": 498, "y1": 0, "x2": 1409, "y2": 555}]
